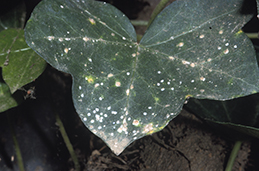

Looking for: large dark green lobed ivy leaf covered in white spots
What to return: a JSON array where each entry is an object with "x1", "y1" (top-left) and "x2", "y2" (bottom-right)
[{"x1": 25, "y1": 0, "x2": 259, "y2": 154}]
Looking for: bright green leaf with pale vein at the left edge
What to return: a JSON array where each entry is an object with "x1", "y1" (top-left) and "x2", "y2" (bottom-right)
[{"x1": 0, "y1": 29, "x2": 46, "y2": 93}]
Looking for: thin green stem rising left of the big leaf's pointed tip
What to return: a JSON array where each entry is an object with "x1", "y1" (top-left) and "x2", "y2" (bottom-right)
[{"x1": 56, "y1": 113, "x2": 80, "y2": 171}]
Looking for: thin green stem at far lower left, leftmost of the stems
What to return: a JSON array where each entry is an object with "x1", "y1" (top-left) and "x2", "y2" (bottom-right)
[{"x1": 7, "y1": 112, "x2": 25, "y2": 171}]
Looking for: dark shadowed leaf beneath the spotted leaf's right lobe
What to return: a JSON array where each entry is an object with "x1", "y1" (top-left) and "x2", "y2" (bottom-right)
[{"x1": 185, "y1": 94, "x2": 259, "y2": 140}]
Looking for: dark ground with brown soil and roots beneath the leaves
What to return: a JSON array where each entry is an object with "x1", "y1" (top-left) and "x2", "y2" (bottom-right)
[{"x1": 0, "y1": 0, "x2": 259, "y2": 171}]
